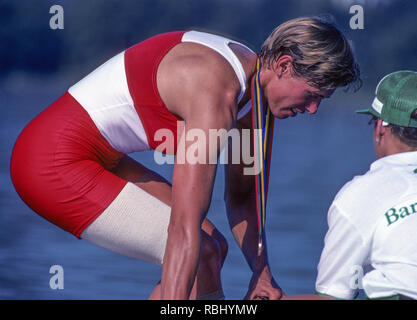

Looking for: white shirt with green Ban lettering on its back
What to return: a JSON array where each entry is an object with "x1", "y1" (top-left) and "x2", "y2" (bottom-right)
[{"x1": 316, "y1": 151, "x2": 417, "y2": 299}]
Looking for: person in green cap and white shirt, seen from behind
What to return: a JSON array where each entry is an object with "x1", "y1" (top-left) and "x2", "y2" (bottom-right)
[{"x1": 316, "y1": 71, "x2": 417, "y2": 299}]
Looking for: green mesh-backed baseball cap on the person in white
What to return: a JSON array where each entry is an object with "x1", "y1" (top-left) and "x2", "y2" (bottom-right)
[{"x1": 356, "y1": 71, "x2": 417, "y2": 128}]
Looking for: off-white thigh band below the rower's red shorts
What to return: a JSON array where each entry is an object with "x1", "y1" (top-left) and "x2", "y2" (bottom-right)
[{"x1": 81, "y1": 182, "x2": 171, "y2": 265}]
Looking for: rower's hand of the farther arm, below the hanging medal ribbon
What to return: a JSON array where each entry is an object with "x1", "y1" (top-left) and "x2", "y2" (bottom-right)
[{"x1": 244, "y1": 267, "x2": 284, "y2": 300}]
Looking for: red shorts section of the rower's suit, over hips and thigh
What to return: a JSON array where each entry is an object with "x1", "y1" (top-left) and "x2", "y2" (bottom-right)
[{"x1": 10, "y1": 92, "x2": 127, "y2": 238}]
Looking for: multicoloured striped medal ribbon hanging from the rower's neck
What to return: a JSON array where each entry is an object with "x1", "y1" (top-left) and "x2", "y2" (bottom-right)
[{"x1": 251, "y1": 58, "x2": 274, "y2": 250}]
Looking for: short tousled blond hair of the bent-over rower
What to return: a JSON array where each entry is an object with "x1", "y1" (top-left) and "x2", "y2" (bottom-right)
[{"x1": 259, "y1": 17, "x2": 362, "y2": 90}]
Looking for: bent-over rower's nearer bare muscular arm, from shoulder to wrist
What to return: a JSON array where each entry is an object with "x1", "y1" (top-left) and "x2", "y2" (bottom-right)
[{"x1": 158, "y1": 46, "x2": 238, "y2": 299}]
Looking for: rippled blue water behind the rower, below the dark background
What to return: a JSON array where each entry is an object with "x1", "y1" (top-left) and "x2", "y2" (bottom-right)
[{"x1": 0, "y1": 74, "x2": 375, "y2": 299}]
